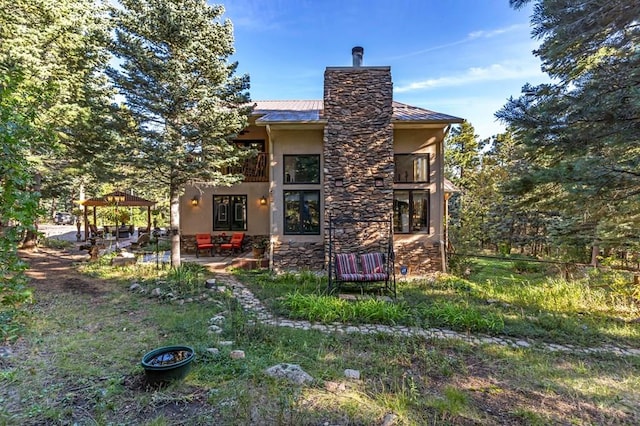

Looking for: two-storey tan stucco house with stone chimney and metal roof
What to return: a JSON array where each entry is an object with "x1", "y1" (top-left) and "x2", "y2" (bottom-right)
[{"x1": 180, "y1": 47, "x2": 463, "y2": 275}]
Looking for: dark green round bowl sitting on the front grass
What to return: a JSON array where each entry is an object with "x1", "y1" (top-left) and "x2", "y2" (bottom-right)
[{"x1": 142, "y1": 346, "x2": 196, "y2": 384}]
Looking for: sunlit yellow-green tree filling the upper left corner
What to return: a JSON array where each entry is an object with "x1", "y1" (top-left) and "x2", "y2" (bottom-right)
[{"x1": 0, "y1": 0, "x2": 111, "y2": 246}]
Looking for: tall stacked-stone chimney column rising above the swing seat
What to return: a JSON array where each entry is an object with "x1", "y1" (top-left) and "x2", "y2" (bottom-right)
[{"x1": 323, "y1": 67, "x2": 394, "y2": 254}]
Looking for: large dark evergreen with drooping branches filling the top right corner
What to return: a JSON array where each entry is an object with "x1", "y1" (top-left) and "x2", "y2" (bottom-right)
[{"x1": 496, "y1": 0, "x2": 640, "y2": 258}]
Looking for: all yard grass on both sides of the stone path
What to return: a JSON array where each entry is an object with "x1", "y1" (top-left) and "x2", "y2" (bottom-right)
[{"x1": 0, "y1": 251, "x2": 640, "y2": 425}]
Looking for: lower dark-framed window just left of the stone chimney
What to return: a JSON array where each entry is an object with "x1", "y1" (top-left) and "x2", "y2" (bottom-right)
[{"x1": 284, "y1": 191, "x2": 320, "y2": 235}]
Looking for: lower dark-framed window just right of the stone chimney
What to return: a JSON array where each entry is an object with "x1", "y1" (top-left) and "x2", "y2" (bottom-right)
[{"x1": 393, "y1": 190, "x2": 429, "y2": 234}]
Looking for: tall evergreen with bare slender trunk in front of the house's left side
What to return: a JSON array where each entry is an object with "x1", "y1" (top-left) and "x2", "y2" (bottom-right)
[{"x1": 108, "y1": 0, "x2": 250, "y2": 266}]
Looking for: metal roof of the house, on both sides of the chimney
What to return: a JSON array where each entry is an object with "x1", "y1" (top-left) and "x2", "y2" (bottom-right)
[{"x1": 253, "y1": 100, "x2": 464, "y2": 123}]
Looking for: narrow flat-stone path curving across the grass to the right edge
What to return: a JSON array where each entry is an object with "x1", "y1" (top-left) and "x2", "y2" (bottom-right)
[{"x1": 216, "y1": 273, "x2": 640, "y2": 356}]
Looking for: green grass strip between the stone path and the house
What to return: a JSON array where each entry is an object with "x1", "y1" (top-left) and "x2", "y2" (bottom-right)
[{"x1": 238, "y1": 259, "x2": 640, "y2": 347}]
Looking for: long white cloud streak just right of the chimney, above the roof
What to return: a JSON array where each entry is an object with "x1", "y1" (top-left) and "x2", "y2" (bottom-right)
[{"x1": 394, "y1": 62, "x2": 543, "y2": 93}]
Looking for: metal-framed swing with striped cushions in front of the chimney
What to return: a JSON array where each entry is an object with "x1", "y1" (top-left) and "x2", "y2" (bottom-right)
[{"x1": 327, "y1": 215, "x2": 396, "y2": 298}]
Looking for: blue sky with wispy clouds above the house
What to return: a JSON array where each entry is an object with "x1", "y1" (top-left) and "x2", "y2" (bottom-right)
[{"x1": 221, "y1": 0, "x2": 548, "y2": 138}]
